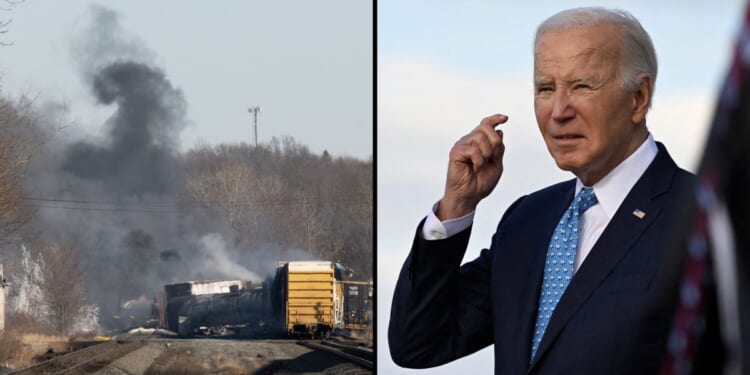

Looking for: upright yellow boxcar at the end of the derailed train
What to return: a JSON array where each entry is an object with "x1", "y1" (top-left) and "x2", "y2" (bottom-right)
[{"x1": 271, "y1": 261, "x2": 342, "y2": 337}]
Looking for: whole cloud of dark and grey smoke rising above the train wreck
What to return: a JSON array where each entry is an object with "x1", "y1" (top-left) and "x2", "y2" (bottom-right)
[{"x1": 20, "y1": 7, "x2": 290, "y2": 328}]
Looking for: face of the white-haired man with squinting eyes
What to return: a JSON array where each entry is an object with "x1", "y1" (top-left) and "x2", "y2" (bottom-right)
[{"x1": 534, "y1": 25, "x2": 645, "y2": 186}]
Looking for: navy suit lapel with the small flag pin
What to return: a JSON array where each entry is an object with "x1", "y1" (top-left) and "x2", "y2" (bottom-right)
[{"x1": 529, "y1": 144, "x2": 677, "y2": 370}]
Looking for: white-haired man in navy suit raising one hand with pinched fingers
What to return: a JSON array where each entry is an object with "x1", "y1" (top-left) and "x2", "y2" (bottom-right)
[{"x1": 389, "y1": 8, "x2": 693, "y2": 374}]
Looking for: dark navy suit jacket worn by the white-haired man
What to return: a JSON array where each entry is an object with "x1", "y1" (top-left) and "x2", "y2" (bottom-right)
[{"x1": 388, "y1": 144, "x2": 694, "y2": 374}]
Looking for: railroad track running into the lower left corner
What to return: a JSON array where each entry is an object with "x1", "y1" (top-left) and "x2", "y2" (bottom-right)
[{"x1": 10, "y1": 341, "x2": 144, "y2": 375}]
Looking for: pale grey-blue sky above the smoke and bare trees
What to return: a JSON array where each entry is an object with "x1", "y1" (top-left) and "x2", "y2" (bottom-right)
[{"x1": 0, "y1": 0, "x2": 373, "y2": 159}]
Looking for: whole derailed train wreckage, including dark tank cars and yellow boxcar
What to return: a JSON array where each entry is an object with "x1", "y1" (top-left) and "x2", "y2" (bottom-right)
[{"x1": 155, "y1": 261, "x2": 372, "y2": 337}]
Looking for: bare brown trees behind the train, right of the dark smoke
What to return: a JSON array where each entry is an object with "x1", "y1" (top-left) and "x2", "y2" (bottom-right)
[{"x1": 179, "y1": 137, "x2": 373, "y2": 279}]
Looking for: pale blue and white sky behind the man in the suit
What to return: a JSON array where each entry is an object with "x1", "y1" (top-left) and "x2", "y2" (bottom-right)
[{"x1": 377, "y1": 0, "x2": 744, "y2": 374}]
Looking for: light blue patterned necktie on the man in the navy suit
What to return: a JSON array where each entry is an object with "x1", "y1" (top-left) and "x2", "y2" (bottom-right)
[{"x1": 530, "y1": 187, "x2": 597, "y2": 361}]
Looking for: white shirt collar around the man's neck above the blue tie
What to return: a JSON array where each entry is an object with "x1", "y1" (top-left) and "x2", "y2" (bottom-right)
[{"x1": 575, "y1": 133, "x2": 659, "y2": 219}]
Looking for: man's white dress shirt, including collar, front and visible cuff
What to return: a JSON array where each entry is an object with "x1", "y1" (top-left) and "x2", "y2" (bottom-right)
[{"x1": 422, "y1": 134, "x2": 658, "y2": 271}]
